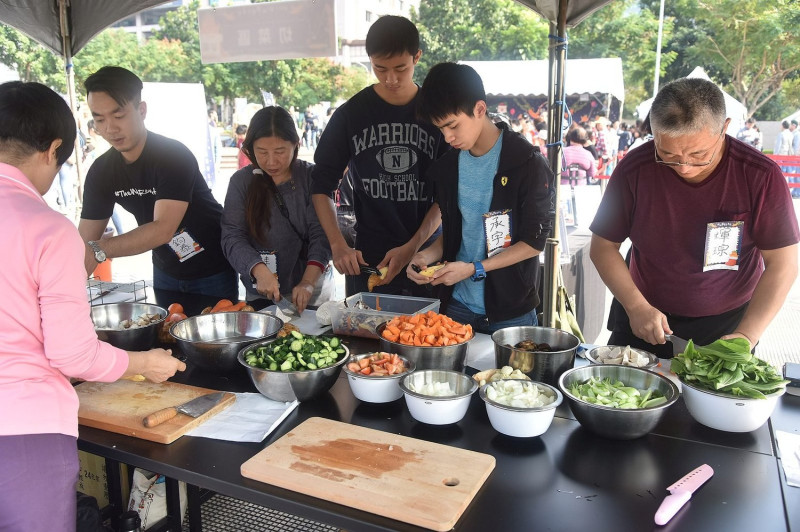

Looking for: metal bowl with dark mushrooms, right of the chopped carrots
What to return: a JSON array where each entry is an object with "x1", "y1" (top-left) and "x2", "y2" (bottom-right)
[{"x1": 492, "y1": 326, "x2": 581, "y2": 386}]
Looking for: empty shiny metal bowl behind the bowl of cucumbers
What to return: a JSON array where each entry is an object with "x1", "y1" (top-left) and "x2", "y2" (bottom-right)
[{"x1": 169, "y1": 312, "x2": 283, "y2": 371}]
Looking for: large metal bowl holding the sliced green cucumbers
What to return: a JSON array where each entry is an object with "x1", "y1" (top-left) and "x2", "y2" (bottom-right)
[{"x1": 237, "y1": 338, "x2": 350, "y2": 402}]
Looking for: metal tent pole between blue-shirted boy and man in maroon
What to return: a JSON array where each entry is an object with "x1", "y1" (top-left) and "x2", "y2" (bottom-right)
[{"x1": 542, "y1": 0, "x2": 569, "y2": 327}]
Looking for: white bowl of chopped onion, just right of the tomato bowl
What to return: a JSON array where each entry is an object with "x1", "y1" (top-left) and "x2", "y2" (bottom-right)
[{"x1": 400, "y1": 369, "x2": 478, "y2": 425}]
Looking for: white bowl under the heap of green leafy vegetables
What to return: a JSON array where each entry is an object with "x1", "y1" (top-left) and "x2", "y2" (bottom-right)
[{"x1": 681, "y1": 379, "x2": 786, "y2": 432}]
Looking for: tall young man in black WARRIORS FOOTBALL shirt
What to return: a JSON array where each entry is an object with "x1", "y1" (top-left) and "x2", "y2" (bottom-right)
[{"x1": 311, "y1": 15, "x2": 448, "y2": 296}]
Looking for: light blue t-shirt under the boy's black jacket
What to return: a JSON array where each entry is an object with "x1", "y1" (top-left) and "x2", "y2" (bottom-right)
[{"x1": 453, "y1": 135, "x2": 503, "y2": 316}]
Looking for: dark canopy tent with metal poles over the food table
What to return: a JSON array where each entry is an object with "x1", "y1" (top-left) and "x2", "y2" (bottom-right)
[{"x1": 0, "y1": 0, "x2": 611, "y2": 327}]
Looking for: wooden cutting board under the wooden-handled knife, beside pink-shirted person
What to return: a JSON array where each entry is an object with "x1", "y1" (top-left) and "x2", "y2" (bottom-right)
[{"x1": 75, "y1": 380, "x2": 236, "y2": 443}]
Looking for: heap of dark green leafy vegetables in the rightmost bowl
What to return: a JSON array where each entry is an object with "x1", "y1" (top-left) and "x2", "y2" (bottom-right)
[{"x1": 672, "y1": 338, "x2": 789, "y2": 399}]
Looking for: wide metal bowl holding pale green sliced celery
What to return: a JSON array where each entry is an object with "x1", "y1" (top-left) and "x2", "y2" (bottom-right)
[{"x1": 558, "y1": 364, "x2": 679, "y2": 440}]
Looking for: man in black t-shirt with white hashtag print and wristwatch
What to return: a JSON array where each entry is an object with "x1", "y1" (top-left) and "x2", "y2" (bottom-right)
[{"x1": 78, "y1": 66, "x2": 238, "y2": 299}]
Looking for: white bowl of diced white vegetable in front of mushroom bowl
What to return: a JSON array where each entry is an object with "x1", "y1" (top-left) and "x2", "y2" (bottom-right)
[{"x1": 480, "y1": 380, "x2": 564, "y2": 438}]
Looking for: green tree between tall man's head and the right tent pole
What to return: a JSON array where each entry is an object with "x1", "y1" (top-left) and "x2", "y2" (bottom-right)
[{"x1": 411, "y1": 0, "x2": 549, "y2": 80}]
